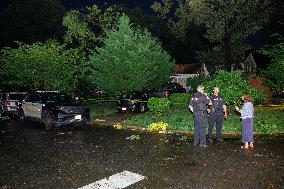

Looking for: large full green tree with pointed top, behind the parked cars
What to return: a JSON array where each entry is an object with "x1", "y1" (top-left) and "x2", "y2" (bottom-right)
[{"x1": 91, "y1": 16, "x2": 173, "y2": 94}]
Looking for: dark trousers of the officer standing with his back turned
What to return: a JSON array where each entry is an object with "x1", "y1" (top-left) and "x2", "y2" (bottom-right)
[{"x1": 193, "y1": 112, "x2": 206, "y2": 145}]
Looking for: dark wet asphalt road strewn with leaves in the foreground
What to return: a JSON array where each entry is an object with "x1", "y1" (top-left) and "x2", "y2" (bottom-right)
[{"x1": 0, "y1": 120, "x2": 284, "y2": 189}]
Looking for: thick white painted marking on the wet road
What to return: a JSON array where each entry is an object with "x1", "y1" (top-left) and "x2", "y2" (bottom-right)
[{"x1": 78, "y1": 171, "x2": 145, "y2": 189}]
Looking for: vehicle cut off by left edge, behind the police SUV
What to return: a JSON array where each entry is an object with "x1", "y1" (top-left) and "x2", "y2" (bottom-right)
[{"x1": 0, "y1": 91, "x2": 27, "y2": 118}]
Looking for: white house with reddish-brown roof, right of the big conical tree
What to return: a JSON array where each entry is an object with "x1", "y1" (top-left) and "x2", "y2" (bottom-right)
[{"x1": 170, "y1": 64, "x2": 209, "y2": 88}]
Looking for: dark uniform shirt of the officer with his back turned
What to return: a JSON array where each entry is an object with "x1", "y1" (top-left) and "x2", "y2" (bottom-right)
[{"x1": 189, "y1": 92, "x2": 210, "y2": 112}]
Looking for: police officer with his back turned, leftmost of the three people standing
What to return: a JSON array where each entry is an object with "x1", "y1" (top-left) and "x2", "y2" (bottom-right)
[{"x1": 189, "y1": 85, "x2": 211, "y2": 148}]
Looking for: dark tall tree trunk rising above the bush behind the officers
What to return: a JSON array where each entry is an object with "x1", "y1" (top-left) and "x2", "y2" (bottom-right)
[{"x1": 224, "y1": 22, "x2": 232, "y2": 72}]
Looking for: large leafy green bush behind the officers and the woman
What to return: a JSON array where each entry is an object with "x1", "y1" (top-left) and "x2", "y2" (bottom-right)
[{"x1": 205, "y1": 71, "x2": 265, "y2": 105}]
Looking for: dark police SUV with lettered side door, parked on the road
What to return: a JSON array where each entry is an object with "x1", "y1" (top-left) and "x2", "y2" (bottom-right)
[{"x1": 19, "y1": 91, "x2": 90, "y2": 130}]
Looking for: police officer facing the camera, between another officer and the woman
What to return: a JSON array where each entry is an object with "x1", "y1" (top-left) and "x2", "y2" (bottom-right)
[{"x1": 208, "y1": 86, "x2": 227, "y2": 142}]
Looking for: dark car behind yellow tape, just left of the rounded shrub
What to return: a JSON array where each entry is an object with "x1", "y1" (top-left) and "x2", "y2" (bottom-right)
[{"x1": 117, "y1": 92, "x2": 152, "y2": 113}]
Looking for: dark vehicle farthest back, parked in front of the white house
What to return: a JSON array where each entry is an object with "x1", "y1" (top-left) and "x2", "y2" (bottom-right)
[{"x1": 152, "y1": 83, "x2": 186, "y2": 97}]
